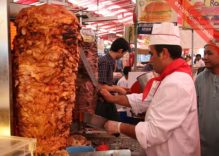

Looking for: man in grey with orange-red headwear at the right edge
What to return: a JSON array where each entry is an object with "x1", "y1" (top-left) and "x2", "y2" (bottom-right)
[{"x1": 195, "y1": 42, "x2": 219, "y2": 156}]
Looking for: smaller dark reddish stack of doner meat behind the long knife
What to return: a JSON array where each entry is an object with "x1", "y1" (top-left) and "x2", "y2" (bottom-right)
[{"x1": 74, "y1": 42, "x2": 98, "y2": 116}]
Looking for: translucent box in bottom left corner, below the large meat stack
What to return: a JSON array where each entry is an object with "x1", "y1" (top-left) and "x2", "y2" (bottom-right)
[{"x1": 0, "y1": 136, "x2": 36, "y2": 156}]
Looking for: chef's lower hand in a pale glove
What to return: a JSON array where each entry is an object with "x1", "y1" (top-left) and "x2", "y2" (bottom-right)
[{"x1": 104, "y1": 120, "x2": 121, "y2": 134}]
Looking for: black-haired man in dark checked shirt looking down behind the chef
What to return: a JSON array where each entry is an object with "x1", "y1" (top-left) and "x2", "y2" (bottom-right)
[{"x1": 95, "y1": 38, "x2": 130, "y2": 121}]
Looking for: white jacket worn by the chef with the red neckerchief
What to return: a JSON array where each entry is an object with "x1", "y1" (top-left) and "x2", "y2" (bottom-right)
[{"x1": 127, "y1": 72, "x2": 200, "y2": 156}]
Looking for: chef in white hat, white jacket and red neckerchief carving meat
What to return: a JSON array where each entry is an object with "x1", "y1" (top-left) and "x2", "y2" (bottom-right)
[{"x1": 100, "y1": 23, "x2": 200, "y2": 156}]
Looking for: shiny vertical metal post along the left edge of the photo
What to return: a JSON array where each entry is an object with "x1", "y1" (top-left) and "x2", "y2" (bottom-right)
[{"x1": 0, "y1": 0, "x2": 12, "y2": 136}]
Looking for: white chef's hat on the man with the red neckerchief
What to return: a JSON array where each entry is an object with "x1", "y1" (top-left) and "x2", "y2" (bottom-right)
[{"x1": 149, "y1": 22, "x2": 181, "y2": 46}]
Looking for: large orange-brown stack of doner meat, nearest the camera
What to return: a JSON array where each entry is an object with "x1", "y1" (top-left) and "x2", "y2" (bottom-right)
[{"x1": 13, "y1": 4, "x2": 81, "y2": 153}]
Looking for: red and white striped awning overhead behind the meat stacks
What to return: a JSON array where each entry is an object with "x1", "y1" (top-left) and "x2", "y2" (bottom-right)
[{"x1": 14, "y1": 0, "x2": 135, "y2": 36}]
